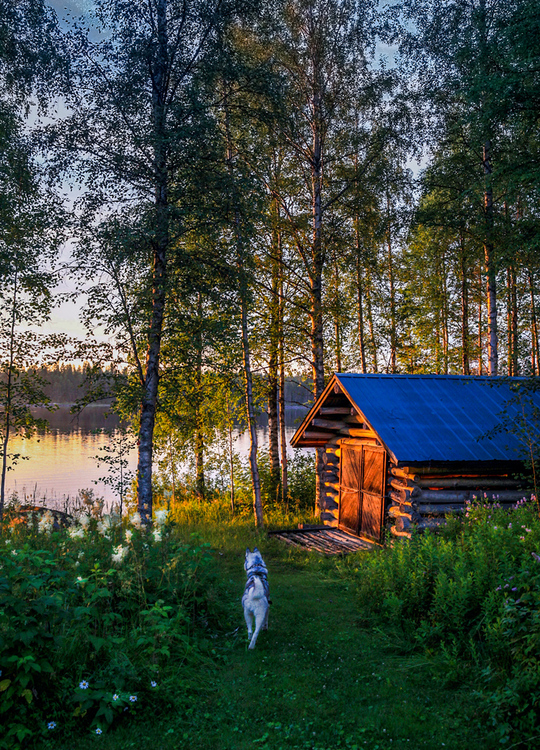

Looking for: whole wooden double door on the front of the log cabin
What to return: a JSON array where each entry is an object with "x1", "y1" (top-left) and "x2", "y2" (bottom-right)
[{"x1": 339, "y1": 444, "x2": 386, "y2": 541}]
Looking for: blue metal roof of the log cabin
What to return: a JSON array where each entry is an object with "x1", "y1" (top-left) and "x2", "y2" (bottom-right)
[{"x1": 335, "y1": 373, "x2": 540, "y2": 463}]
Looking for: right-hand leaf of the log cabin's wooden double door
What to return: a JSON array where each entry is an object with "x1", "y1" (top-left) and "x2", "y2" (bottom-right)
[{"x1": 360, "y1": 446, "x2": 386, "y2": 541}]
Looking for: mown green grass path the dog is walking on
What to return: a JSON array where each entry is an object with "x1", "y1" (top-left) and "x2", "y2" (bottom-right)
[{"x1": 47, "y1": 526, "x2": 490, "y2": 750}]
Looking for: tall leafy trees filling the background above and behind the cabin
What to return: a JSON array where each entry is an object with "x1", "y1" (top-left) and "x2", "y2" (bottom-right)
[{"x1": 0, "y1": 0, "x2": 540, "y2": 524}]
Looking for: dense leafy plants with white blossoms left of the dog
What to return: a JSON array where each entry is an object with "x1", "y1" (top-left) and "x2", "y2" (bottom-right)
[{"x1": 0, "y1": 519, "x2": 223, "y2": 750}]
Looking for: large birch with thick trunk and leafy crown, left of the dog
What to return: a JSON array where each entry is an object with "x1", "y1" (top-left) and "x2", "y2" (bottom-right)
[{"x1": 58, "y1": 0, "x2": 252, "y2": 523}]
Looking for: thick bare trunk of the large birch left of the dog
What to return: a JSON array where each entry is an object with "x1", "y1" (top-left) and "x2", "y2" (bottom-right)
[{"x1": 137, "y1": 0, "x2": 169, "y2": 524}]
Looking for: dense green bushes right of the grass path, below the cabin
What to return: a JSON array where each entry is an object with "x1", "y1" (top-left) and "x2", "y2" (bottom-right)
[{"x1": 346, "y1": 499, "x2": 540, "y2": 747}]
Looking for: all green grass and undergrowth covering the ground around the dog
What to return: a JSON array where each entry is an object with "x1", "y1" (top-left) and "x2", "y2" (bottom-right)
[{"x1": 0, "y1": 499, "x2": 540, "y2": 750}]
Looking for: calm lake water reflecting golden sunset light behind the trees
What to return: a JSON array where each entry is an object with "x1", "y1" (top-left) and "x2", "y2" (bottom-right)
[{"x1": 6, "y1": 406, "x2": 305, "y2": 507}]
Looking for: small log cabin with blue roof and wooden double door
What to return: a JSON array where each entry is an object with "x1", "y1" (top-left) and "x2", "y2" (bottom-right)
[{"x1": 291, "y1": 373, "x2": 540, "y2": 542}]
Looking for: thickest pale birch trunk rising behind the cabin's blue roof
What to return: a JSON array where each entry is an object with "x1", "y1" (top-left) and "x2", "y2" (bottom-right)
[{"x1": 483, "y1": 141, "x2": 498, "y2": 376}]
